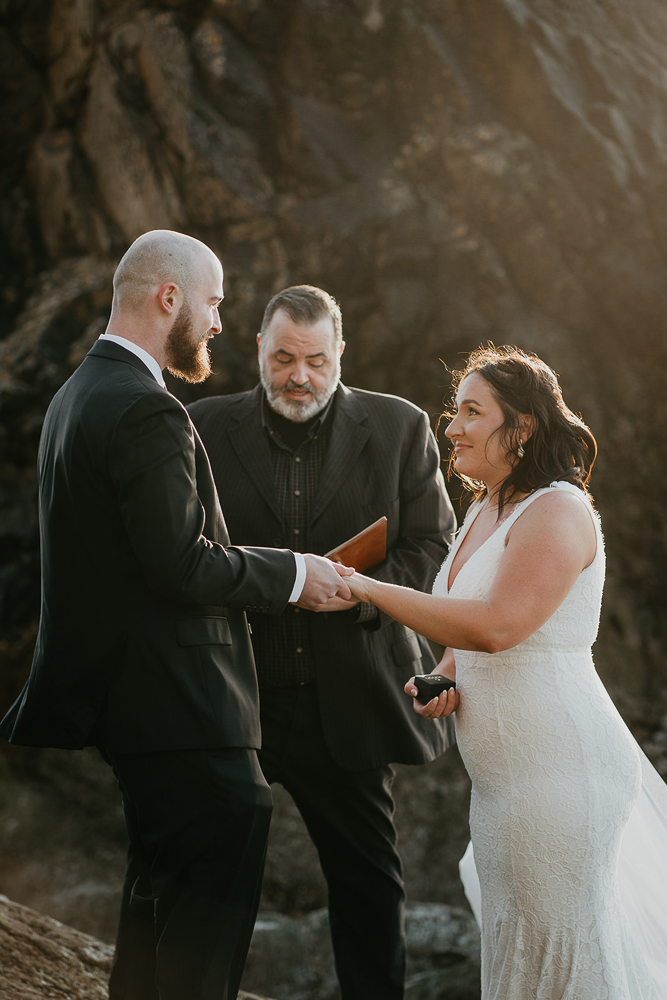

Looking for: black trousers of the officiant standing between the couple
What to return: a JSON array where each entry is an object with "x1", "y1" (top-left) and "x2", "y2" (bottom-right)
[{"x1": 259, "y1": 685, "x2": 405, "y2": 1000}]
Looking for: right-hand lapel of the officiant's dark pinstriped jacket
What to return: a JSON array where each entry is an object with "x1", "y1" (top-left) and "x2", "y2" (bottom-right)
[{"x1": 310, "y1": 385, "x2": 371, "y2": 524}]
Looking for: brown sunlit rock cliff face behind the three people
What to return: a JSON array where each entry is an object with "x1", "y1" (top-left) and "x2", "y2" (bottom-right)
[{"x1": 0, "y1": 0, "x2": 667, "y2": 988}]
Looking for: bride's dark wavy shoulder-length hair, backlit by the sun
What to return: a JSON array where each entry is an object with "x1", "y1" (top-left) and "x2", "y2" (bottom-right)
[{"x1": 443, "y1": 344, "x2": 597, "y2": 517}]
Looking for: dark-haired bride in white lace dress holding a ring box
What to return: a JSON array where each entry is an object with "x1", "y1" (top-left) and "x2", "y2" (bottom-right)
[{"x1": 348, "y1": 348, "x2": 667, "y2": 1000}]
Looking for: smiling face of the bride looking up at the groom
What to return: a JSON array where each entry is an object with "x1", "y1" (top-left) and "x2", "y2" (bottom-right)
[{"x1": 445, "y1": 372, "x2": 513, "y2": 491}]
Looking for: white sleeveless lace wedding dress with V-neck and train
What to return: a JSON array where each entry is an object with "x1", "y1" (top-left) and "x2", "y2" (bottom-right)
[{"x1": 433, "y1": 483, "x2": 667, "y2": 1000}]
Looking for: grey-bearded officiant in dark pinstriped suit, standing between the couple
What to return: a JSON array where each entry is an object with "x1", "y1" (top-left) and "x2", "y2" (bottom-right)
[{"x1": 189, "y1": 285, "x2": 455, "y2": 1000}]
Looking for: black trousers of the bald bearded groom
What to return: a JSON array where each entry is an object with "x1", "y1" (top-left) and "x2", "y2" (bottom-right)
[{"x1": 103, "y1": 747, "x2": 272, "y2": 1000}]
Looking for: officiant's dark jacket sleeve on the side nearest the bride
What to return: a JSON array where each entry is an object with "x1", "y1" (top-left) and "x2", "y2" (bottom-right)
[{"x1": 362, "y1": 412, "x2": 456, "y2": 614}]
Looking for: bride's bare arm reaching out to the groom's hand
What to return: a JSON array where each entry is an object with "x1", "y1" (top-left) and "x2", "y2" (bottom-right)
[{"x1": 346, "y1": 491, "x2": 596, "y2": 653}]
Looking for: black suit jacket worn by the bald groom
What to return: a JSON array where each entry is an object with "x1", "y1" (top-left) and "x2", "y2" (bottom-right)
[{"x1": 0, "y1": 341, "x2": 296, "y2": 753}]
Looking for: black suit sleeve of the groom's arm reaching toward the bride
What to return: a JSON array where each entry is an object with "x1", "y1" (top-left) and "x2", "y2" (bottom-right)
[{"x1": 108, "y1": 393, "x2": 296, "y2": 614}]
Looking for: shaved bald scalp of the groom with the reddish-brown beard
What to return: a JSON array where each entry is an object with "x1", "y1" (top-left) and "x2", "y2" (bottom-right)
[{"x1": 113, "y1": 229, "x2": 219, "y2": 311}]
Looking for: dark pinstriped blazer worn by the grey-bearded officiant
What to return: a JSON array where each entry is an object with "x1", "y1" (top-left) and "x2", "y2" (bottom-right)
[{"x1": 189, "y1": 386, "x2": 455, "y2": 770}]
